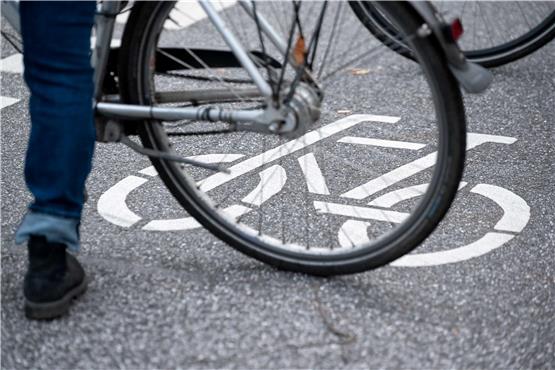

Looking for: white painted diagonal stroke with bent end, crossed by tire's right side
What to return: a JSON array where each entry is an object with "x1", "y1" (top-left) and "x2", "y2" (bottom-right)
[{"x1": 341, "y1": 133, "x2": 516, "y2": 199}]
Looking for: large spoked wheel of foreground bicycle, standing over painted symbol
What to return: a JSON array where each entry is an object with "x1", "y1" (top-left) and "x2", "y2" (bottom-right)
[{"x1": 119, "y1": 2, "x2": 465, "y2": 275}]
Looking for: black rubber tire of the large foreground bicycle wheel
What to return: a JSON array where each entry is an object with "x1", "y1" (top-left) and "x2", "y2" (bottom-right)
[{"x1": 119, "y1": 2, "x2": 465, "y2": 276}]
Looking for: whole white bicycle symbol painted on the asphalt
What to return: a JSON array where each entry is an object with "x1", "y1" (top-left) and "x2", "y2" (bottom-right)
[{"x1": 97, "y1": 115, "x2": 530, "y2": 267}]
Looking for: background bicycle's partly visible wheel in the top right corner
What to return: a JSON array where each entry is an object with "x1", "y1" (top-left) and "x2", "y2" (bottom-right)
[{"x1": 356, "y1": 1, "x2": 555, "y2": 67}]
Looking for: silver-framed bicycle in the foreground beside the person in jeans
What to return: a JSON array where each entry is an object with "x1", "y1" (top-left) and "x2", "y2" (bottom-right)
[{"x1": 3, "y1": 0, "x2": 491, "y2": 275}]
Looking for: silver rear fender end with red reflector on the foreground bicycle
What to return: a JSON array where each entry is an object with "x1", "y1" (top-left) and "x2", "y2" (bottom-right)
[{"x1": 410, "y1": 1, "x2": 493, "y2": 94}]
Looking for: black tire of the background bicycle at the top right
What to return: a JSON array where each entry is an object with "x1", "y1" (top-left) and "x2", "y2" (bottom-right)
[{"x1": 365, "y1": 4, "x2": 555, "y2": 68}]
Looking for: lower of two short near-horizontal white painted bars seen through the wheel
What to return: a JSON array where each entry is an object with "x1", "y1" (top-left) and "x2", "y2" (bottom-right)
[{"x1": 314, "y1": 201, "x2": 409, "y2": 223}]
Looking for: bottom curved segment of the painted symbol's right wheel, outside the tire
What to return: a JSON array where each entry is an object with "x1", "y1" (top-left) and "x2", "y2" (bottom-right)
[{"x1": 390, "y1": 232, "x2": 514, "y2": 267}]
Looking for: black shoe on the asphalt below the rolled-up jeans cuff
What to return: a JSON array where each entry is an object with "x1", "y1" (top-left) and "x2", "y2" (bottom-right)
[{"x1": 23, "y1": 236, "x2": 87, "y2": 320}]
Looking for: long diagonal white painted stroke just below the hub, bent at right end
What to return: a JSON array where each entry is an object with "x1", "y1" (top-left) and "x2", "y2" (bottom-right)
[{"x1": 200, "y1": 114, "x2": 400, "y2": 192}]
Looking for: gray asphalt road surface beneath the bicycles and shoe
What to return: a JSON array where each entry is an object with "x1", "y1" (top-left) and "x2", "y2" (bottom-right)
[{"x1": 0, "y1": 3, "x2": 555, "y2": 369}]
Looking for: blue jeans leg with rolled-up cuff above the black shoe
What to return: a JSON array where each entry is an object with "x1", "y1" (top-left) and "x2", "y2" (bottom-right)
[{"x1": 16, "y1": 1, "x2": 96, "y2": 250}]
